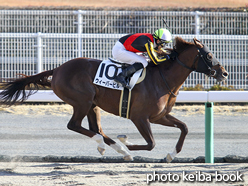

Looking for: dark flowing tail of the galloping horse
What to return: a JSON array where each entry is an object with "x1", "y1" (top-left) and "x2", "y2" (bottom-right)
[{"x1": 0, "y1": 70, "x2": 53, "y2": 106}]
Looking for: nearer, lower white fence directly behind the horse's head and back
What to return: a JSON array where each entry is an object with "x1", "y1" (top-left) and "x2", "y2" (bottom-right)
[{"x1": 0, "y1": 32, "x2": 248, "y2": 89}]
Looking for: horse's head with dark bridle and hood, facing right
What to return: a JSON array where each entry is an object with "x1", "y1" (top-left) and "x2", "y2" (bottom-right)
[{"x1": 194, "y1": 38, "x2": 228, "y2": 82}]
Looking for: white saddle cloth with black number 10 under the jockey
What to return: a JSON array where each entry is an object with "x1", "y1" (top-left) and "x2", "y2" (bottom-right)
[{"x1": 93, "y1": 60, "x2": 146, "y2": 90}]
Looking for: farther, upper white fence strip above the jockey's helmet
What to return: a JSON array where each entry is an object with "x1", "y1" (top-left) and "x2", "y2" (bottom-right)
[{"x1": 0, "y1": 10, "x2": 248, "y2": 35}]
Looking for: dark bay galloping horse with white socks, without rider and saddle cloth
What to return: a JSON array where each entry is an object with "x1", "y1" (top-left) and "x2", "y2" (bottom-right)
[{"x1": 0, "y1": 37, "x2": 228, "y2": 162}]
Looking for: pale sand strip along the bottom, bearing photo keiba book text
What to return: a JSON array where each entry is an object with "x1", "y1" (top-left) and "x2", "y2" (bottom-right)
[{"x1": 0, "y1": 162, "x2": 248, "y2": 186}]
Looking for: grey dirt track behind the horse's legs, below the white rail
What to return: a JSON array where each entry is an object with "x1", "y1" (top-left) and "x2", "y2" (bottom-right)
[{"x1": 0, "y1": 105, "x2": 248, "y2": 158}]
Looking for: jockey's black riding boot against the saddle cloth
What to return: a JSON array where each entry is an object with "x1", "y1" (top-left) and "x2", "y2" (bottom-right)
[{"x1": 114, "y1": 63, "x2": 144, "y2": 89}]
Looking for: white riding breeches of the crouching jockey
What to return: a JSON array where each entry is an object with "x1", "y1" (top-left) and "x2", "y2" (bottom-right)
[{"x1": 112, "y1": 41, "x2": 148, "y2": 68}]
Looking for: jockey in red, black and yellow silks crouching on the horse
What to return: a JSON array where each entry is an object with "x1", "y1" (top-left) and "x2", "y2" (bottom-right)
[{"x1": 112, "y1": 28, "x2": 172, "y2": 89}]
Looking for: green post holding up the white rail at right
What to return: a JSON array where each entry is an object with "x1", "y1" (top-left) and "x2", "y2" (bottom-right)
[{"x1": 205, "y1": 102, "x2": 214, "y2": 163}]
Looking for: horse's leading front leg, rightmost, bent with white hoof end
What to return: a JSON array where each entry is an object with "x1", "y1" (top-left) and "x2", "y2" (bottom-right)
[{"x1": 153, "y1": 114, "x2": 188, "y2": 162}]
